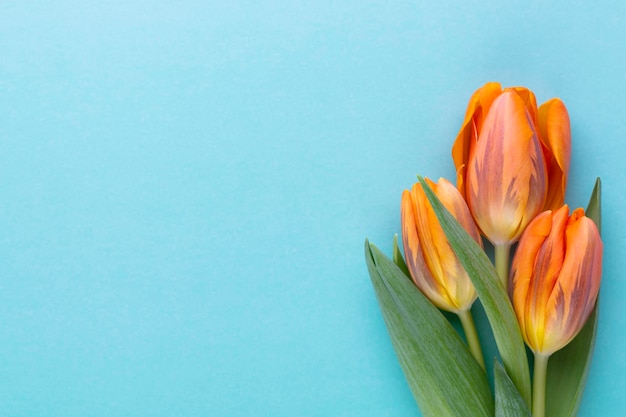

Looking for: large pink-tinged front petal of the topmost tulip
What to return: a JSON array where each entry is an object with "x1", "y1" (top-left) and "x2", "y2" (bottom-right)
[{"x1": 466, "y1": 90, "x2": 547, "y2": 245}]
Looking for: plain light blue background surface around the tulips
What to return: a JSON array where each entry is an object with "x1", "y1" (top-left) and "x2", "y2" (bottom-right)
[{"x1": 0, "y1": 0, "x2": 626, "y2": 417}]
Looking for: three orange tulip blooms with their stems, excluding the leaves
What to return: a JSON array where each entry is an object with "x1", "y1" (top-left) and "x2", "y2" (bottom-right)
[{"x1": 368, "y1": 83, "x2": 603, "y2": 417}]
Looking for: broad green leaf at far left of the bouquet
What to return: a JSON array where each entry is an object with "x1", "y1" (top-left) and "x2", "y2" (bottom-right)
[{"x1": 365, "y1": 240, "x2": 494, "y2": 417}]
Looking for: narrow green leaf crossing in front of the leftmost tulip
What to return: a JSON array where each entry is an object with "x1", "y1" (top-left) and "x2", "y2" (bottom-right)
[{"x1": 419, "y1": 177, "x2": 531, "y2": 407}]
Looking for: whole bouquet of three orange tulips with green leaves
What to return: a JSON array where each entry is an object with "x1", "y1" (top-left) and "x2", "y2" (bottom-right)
[{"x1": 365, "y1": 83, "x2": 602, "y2": 417}]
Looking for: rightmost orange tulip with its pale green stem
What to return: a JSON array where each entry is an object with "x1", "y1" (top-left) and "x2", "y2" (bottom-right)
[{"x1": 510, "y1": 205, "x2": 602, "y2": 417}]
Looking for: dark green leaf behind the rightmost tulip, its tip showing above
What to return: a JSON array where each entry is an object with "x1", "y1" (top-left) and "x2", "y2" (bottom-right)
[{"x1": 546, "y1": 178, "x2": 602, "y2": 417}]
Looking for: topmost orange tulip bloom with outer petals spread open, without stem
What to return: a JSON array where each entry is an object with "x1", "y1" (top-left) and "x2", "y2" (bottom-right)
[{"x1": 452, "y1": 83, "x2": 571, "y2": 245}]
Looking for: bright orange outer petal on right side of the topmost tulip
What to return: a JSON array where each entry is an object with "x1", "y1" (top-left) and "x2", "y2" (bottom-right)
[{"x1": 537, "y1": 98, "x2": 572, "y2": 210}]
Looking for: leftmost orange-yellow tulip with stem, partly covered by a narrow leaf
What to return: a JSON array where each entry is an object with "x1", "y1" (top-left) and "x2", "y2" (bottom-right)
[{"x1": 401, "y1": 178, "x2": 485, "y2": 368}]
